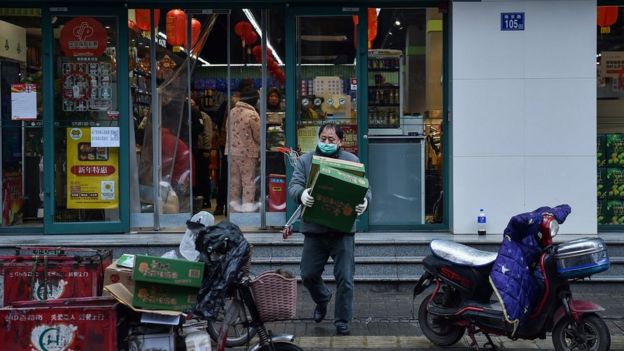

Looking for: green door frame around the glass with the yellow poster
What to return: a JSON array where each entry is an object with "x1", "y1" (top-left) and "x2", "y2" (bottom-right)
[{"x1": 42, "y1": 6, "x2": 130, "y2": 234}]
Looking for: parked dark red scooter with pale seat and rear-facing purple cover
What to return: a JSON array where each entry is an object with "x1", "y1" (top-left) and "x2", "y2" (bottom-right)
[{"x1": 414, "y1": 205, "x2": 611, "y2": 351}]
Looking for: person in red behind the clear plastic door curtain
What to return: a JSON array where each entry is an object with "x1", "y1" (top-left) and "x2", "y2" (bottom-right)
[{"x1": 161, "y1": 102, "x2": 195, "y2": 210}]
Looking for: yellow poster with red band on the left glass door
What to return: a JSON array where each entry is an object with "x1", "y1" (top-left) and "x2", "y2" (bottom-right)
[{"x1": 67, "y1": 128, "x2": 119, "y2": 209}]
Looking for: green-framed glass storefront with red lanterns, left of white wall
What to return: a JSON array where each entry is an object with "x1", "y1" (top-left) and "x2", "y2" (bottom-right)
[{"x1": 0, "y1": 1, "x2": 448, "y2": 233}]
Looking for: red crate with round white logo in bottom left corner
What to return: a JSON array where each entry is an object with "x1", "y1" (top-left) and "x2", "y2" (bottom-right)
[{"x1": 0, "y1": 297, "x2": 117, "y2": 351}]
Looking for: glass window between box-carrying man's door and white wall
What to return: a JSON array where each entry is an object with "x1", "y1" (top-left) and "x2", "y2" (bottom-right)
[{"x1": 367, "y1": 8, "x2": 444, "y2": 226}]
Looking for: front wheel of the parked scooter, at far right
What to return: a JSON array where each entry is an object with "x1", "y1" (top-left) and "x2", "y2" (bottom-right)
[{"x1": 552, "y1": 313, "x2": 611, "y2": 351}]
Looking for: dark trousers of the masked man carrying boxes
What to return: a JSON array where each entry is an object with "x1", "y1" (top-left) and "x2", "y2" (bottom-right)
[{"x1": 301, "y1": 233, "x2": 355, "y2": 322}]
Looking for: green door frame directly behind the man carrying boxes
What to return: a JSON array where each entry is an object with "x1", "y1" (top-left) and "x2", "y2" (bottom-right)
[{"x1": 285, "y1": 6, "x2": 368, "y2": 232}]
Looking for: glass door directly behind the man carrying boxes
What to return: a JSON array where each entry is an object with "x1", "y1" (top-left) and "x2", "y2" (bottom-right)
[{"x1": 287, "y1": 8, "x2": 368, "y2": 230}]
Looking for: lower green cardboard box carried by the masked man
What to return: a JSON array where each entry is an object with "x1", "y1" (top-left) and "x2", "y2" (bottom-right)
[{"x1": 302, "y1": 164, "x2": 368, "y2": 233}]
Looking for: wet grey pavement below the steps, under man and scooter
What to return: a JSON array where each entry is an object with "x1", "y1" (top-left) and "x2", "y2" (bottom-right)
[{"x1": 256, "y1": 283, "x2": 624, "y2": 351}]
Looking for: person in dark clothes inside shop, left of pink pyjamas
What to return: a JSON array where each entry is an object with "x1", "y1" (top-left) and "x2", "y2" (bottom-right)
[{"x1": 191, "y1": 99, "x2": 214, "y2": 208}]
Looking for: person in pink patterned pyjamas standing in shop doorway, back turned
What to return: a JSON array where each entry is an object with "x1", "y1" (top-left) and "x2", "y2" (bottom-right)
[{"x1": 225, "y1": 87, "x2": 260, "y2": 212}]
